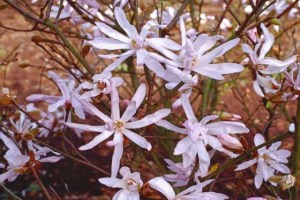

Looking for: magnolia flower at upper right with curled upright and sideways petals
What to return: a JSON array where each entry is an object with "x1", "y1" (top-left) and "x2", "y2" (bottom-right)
[{"x1": 242, "y1": 24, "x2": 297, "y2": 74}]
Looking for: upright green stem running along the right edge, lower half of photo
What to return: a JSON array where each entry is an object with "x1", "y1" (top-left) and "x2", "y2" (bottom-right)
[{"x1": 292, "y1": 97, "x2": 300, "y2": 200}]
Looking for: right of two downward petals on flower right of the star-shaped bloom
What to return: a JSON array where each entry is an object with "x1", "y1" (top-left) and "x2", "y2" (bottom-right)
[{"x1": 197, "y1": 141, "x2": 210, "y2": 176}]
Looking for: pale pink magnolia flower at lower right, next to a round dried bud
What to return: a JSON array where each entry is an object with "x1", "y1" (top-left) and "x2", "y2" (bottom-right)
[{"x1": 235, "y1": 134, "x2": 291, "y2": 189}]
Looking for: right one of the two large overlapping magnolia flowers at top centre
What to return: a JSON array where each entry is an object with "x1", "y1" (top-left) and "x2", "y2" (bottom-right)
[{"x1": 148, "y1": 18, "x2": 244, "y2": 80}]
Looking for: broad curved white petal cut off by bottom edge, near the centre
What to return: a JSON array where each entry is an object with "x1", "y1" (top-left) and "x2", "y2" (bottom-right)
[{"x1": 148, "y1": 177, "x2": 176, "y2": 200}]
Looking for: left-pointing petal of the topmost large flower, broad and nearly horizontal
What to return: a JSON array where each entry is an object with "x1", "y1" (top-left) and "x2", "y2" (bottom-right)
[{"x1": 88, "y1": 37, "x2": 131, "y2": 50}]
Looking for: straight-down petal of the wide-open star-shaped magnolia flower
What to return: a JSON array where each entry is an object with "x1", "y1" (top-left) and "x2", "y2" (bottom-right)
[{"x1": 111, "y1": 133, "x2": 124, "y2": 178}]
